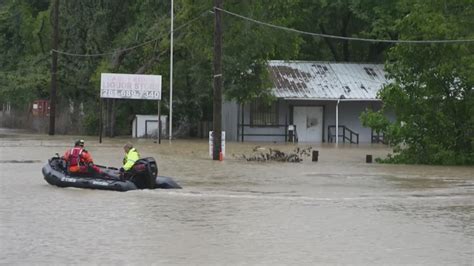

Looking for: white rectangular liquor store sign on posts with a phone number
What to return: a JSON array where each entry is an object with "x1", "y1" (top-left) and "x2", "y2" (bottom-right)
[{"x1": 100, "y1": 73, "x2": 161, "y2": 100}]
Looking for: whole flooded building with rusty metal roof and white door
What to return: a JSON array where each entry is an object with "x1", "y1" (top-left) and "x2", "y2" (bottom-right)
[{"x1": 222, "y1": 61, "x2": 389, "y2": 143}]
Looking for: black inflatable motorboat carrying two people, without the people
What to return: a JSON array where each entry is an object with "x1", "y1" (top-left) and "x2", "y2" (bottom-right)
[{"x1": 42, "y1": 156, "x2": 181, "y2": 191}]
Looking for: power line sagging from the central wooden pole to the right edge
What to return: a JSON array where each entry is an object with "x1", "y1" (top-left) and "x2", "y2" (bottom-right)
[{"x1": 214, "y1": 7, "x2": 474, "y2": 44}]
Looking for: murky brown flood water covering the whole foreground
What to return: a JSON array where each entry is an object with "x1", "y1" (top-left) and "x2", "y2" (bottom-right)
[{"x1": 0, "y1": 130, "x2": 474, "y2": 265}]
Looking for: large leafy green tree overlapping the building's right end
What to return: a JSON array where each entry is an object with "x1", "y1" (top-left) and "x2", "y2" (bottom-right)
[{"x1": 363, "y1": 0, "x2": 474, "y2": 164}]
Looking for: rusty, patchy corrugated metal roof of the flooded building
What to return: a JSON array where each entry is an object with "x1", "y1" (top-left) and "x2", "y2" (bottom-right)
[{"x1": 268, "y1": 61, "x2": 389, "y2": 100}]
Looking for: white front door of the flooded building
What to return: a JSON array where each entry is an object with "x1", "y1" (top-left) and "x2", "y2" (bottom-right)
[{"x1": 293, "y1": 106, "x2": 323, "y2": 142}]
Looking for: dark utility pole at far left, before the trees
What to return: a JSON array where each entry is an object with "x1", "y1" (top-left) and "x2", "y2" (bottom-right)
[{"x1": 49, "y1": 0, "x2": 59, "y2": 136}]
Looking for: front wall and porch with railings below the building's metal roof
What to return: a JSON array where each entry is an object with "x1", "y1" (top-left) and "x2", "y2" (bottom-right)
[{"x1": 223, "y1": 99, "x2": 381, "y2": 144}]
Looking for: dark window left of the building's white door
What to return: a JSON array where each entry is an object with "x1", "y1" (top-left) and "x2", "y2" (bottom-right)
[{"x1": 250, "y1": 100, "x2": 278, "y2": 126}]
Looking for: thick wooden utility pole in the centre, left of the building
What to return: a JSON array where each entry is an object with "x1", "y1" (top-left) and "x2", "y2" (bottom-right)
[{"x1": 212, "y1": 0, "x2": 222, "y2": 160}]
